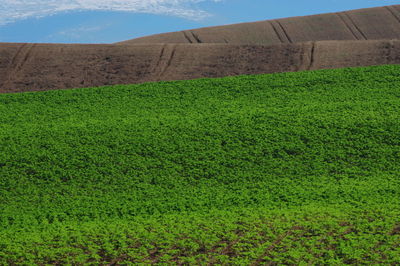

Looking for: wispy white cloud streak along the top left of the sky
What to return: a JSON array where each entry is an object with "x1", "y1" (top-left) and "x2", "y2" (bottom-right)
[{"x1": 0, "y1": 0, "x2": 220, "y2": 25}]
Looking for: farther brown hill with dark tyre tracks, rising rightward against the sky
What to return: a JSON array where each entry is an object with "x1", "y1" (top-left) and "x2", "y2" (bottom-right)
[{"x1": 121, "y1": 5, "x2": 400, "y2": 45}]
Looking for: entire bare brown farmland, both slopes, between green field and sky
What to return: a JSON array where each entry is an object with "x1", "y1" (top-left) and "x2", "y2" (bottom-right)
[{"x1": 0, "y1": 6, "x2": 400, "y2": 92}]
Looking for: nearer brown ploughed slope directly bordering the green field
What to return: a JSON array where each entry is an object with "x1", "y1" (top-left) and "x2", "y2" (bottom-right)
[{"x1": 0, "y1": 40, "x2": 400, "y2": 92}]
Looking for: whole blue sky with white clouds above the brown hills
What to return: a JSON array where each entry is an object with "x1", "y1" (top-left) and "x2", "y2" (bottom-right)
[{"x1": 0, "y1": 0, "x2": 400, "y2": 43}]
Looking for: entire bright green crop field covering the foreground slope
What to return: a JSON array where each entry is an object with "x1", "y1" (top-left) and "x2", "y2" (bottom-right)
[{"x1": 0, "y1": 65, "x2": 400, "y2": 265}]
